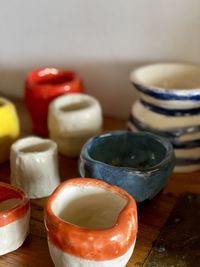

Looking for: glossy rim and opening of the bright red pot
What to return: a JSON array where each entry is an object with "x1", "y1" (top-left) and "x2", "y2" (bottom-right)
[{"x1": 26, "y1": 68, "x2": 83, "y2": 92}]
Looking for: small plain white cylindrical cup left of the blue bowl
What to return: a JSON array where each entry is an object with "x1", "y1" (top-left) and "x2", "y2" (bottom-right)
[{"x1": 10, "y1": 136, "x2": 60, "y2": 198}]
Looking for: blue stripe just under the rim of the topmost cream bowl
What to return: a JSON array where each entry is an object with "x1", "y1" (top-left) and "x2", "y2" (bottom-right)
[{"x1": 133, "y1": 82, "x2": 200, "y2": 101}]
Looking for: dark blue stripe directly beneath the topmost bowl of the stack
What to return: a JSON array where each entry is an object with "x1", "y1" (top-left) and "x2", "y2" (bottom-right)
[{"x1": 140, "y1": 100, "x2": 200, "y2": 117}]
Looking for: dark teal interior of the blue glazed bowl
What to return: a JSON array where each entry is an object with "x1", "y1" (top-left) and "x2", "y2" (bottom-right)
[{"x1": 88, "y1": 132, "x2": 167, "y2": 170}]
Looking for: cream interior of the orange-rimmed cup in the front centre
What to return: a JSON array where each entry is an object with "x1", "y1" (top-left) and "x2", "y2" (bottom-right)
[{"x1": 52, "y1": 185, "x2": 127, "y2": 229}]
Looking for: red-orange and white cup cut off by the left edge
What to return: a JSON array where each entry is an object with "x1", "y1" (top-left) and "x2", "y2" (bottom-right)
[{"x1": 0, "y1": 182, "x2": 30, "y2": 256}]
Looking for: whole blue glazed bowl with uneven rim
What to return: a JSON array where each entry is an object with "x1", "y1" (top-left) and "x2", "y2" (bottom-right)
[{"x1": 79, "y1": 131, "x2": 174, "y2": 202}]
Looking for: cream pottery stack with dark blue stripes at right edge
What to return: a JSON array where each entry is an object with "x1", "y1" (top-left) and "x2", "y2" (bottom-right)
[{"x1": 128, "y1": 63, "x2": 200, "y2": 172}]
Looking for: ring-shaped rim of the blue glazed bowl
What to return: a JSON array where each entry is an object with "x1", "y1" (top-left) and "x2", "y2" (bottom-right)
[{"x1": 80, "y1": 131, "x2": 174, "y2": 174}]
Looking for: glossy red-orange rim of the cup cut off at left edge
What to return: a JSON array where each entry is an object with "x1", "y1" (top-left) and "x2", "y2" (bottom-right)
[{"x1": 0, "y1": 182, "x2": 30, "y2": 227}]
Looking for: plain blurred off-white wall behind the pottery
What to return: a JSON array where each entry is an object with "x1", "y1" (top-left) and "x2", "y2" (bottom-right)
[{"x1": 0, "y1": 0, "x2": 200, "y2": 118}]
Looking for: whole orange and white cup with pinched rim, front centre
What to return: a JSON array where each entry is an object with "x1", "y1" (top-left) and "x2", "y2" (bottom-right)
[{"x1": 45, "y1": 178, "x2": 138, "y2": 267}]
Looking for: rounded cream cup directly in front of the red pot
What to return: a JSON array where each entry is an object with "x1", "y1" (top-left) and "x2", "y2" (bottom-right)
[{"x1": 48, "y1": 94, "x2": 102, "y2": 157}]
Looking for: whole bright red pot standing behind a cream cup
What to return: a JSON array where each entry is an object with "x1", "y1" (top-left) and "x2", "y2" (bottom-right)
[{"x1": 25, "y1": 68, "x2": 83, "y2": 136}]
